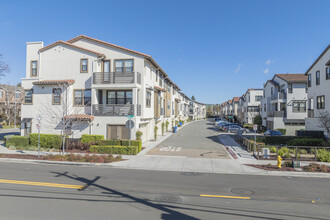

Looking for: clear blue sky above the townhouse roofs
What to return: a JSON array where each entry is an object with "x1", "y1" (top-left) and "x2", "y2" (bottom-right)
[{"x1": 0, "y1": 0, "x2": 330, "y2": 103}]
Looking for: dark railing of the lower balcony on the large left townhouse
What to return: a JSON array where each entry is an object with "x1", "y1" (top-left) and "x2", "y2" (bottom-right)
[{"x1": 92, "y1": 104, "x2": 141, "y2": 116}]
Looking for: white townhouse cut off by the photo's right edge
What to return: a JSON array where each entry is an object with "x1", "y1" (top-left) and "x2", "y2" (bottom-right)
[{"x1": 305, "y1": 45, "x2": 330, "y2": 138}]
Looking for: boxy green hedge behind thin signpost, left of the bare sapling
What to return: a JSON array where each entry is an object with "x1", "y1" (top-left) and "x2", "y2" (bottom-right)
[{"x1": 30, "y1": 133, "x2": 62, "y2": 149}]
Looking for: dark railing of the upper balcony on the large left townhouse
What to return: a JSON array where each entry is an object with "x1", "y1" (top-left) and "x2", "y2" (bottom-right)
[{"x1": 93, "y1": 72, "x2": 141, "y2": 84}]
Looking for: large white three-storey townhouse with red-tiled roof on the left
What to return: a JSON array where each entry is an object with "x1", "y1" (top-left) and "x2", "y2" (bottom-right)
[{"x1": 21, "y1": 35, "x2": 204, "y2": 141}]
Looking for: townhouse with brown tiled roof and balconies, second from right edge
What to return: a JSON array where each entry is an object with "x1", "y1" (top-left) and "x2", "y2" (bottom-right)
[{"x1": 261, "y1": 74, "x2": 307, "y2": 135}]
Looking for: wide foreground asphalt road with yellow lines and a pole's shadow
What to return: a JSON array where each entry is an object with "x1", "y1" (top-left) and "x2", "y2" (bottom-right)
[{"x1": 0, "y1": 162, "x2": 330, "y2": 220}]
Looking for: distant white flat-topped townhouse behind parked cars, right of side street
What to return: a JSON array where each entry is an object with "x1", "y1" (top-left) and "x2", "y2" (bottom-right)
[{"x1": 241, "y1": 89, "x2": 263, "y2": 124}]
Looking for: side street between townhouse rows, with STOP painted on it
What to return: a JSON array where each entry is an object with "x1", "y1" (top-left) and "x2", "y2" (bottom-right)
[{"x1": 148, "y1": 120, "x2": 230, "y2": 159}]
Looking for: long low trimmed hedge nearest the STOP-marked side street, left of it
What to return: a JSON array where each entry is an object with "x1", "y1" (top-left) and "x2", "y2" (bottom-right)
[{"x1": 89, "y1": 145, "x2": 138, "y2": 155}]
